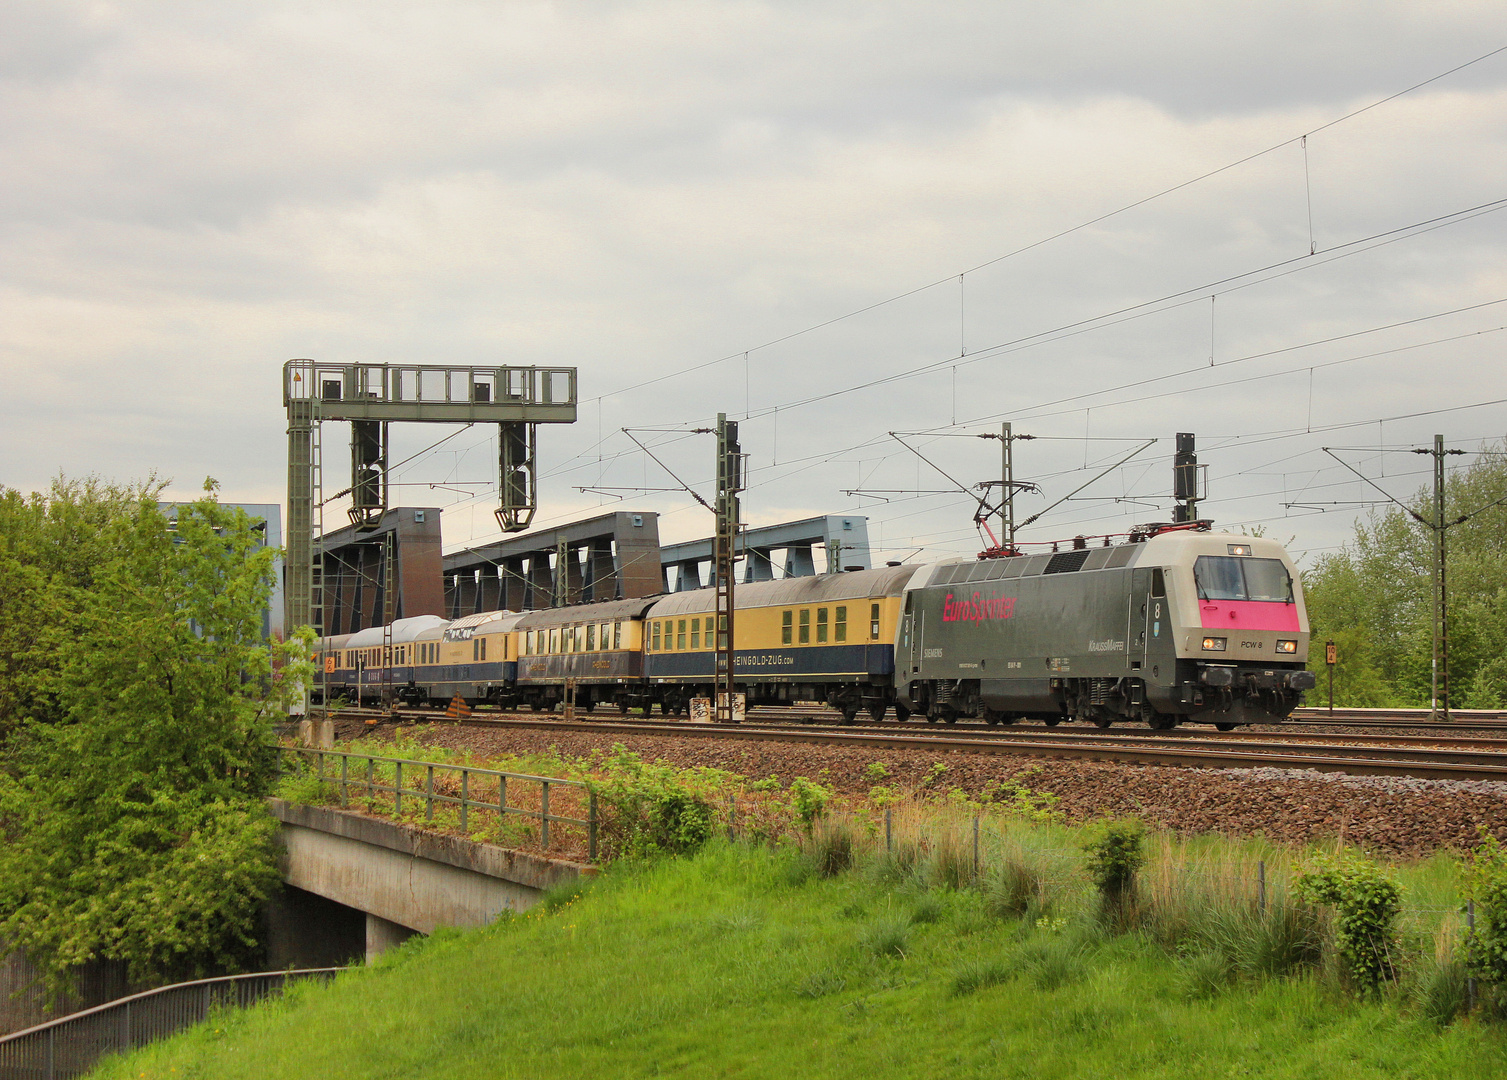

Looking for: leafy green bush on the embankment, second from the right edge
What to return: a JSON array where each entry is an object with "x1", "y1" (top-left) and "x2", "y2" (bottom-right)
[{"x1": 1295, "y1": 857, "x2": 1402, "y2": 990}]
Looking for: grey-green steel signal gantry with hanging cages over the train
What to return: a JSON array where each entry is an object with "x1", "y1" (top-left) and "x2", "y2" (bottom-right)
[{"x1": 283, "y1": 360, "x2": 576, "y2": 710}]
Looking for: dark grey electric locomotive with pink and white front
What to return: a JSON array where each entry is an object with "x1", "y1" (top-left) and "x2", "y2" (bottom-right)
[{"x1": 895, "y1": 530, "x2": 1313, "y2": 728}]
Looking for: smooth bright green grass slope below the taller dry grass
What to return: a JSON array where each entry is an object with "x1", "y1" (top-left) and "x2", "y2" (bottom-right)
[{"x1": 91, "y1": 844, "x2": 1507, "y2": 1080}]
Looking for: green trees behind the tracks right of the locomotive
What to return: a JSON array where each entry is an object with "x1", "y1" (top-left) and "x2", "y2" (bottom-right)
[{"x1": 1304, "y1": 444, "x2": 1507, "y2": 708}]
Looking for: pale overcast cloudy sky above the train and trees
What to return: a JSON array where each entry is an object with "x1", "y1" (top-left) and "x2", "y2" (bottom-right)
[{"x1": 0, "y1": 0, "x2": 1507, "y2": 569}]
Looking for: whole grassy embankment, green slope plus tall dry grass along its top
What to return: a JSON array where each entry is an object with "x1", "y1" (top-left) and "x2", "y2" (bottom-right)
[{"x1": 101, "y1": 789, "x2": 1507, "y2": 1080}]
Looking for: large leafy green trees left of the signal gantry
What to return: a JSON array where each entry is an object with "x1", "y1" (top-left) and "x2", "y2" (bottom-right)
[{"x1": 0, "y1": 482, "x2": 309, "y2": 990}]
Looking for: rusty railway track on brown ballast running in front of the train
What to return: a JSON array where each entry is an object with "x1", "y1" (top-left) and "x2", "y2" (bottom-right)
[{"x1": 320, "y1": 709, "x2": 1507, "y2": 782}]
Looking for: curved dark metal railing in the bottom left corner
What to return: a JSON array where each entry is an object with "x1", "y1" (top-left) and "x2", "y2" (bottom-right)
[{"x1": 0, "y1": 967, "x2": 345, "y2": 1080}]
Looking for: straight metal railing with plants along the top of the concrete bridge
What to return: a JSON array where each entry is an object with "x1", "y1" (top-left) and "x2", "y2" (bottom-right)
[{"x1": 277, "y1": 746, "x2": 597, "y2": 862}]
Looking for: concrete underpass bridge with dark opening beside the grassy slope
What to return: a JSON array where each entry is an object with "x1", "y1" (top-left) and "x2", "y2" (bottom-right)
[{"x1": 267, "y1": 798, "x2": 595, "y2": 969}]
